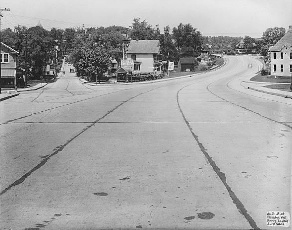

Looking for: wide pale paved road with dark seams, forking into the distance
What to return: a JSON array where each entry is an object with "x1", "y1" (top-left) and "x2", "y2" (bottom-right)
[{"x1": 0, "y1": 56, "x2": 292, "y2": 230}]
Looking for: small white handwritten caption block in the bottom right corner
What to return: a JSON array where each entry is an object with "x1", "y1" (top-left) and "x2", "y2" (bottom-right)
[{"x1": 267, "y1": 211, "x2": 290, "y2": 227}]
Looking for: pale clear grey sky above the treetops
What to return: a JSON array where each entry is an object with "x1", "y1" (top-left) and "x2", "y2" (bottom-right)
[{"x1": 0, "y1": 0, "x2": 292, "y2": 37}]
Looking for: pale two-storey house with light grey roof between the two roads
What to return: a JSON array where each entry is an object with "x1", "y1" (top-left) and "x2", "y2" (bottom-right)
[{"x1": 126, "y1": 40, "x2": 161, "y2": 73}]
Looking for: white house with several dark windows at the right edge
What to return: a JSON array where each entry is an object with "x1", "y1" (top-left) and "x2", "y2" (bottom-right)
[{"x1": 269, "y1": 26, "x2": 292, "y2": 76}]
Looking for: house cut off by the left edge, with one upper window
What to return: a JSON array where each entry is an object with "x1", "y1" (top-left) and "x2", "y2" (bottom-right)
[{"x1": 1, "y1": 42, "x2": 18, "y2": 88}]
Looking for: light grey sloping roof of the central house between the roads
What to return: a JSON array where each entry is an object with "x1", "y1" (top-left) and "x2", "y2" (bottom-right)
[{"x1": 127, "y1": 40, "x2": 159, "y2": 54}]
